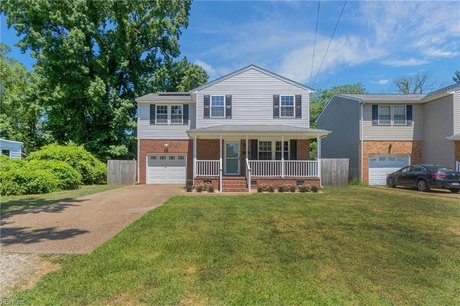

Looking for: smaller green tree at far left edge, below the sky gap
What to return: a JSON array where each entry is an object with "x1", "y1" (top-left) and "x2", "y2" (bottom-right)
[{"x1": 0, "y1": 43, "x2": 51, "y2": 153}]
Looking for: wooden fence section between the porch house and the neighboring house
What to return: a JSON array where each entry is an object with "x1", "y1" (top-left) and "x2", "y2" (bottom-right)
[{"x1": 321, "y1": 158, "x2": 349, "y2": 186}]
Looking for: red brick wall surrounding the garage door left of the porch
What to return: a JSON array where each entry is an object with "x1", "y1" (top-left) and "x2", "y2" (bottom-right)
[{"x1": 138, "y1": 139, "x2": 193, "y2": 184}]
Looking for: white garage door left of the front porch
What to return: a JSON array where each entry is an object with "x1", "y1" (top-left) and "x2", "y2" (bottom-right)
[{"x1": 147, "y1": 154, "x2": 187, "y2": 184}]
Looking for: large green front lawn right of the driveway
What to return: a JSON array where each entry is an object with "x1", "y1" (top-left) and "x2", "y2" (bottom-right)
[{"x1": 6, "y1": 187, "x2": 460, "y2": 305}]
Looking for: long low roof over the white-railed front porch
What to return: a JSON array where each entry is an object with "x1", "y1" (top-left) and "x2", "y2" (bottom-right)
[{"x1": 187, "y1": 125, "x2": 330, "y2": 138}]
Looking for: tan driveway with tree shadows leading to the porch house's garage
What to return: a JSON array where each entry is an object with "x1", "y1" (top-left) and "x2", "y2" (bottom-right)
[{"x1": 0, "y1": 185, "x2": 183, "y2": 254}]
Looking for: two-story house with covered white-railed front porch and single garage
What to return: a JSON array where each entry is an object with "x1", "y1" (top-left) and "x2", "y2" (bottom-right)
[{"x1": 136, "y1": 65, "x2": 328, "y2": 191}]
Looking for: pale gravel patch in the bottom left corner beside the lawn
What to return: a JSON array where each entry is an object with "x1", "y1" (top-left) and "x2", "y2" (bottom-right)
[{"x1": 0, "y1": 253, "x2": 61, "y2": 297}]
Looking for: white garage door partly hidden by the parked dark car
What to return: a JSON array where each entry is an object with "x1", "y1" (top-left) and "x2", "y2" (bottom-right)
[{"x1": 369, "y1": 155, "x2": 410, "y2": 185}]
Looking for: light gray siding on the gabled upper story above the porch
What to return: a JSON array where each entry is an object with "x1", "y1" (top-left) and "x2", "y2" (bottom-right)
[{"x1": 196, "y1": 69, "x2": 310, "y2": 128}]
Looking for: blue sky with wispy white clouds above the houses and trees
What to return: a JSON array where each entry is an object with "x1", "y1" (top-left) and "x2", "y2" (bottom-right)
[{"x1": 0, "y1": 1, "x2": 460, "y2": 93}]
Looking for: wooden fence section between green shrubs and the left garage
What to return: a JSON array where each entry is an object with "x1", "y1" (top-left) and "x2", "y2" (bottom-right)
[{"x1": 107, "y1": 160, "x2": 137, "y2": 185}]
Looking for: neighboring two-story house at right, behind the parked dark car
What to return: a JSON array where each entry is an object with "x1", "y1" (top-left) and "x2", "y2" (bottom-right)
[{"x1": 317, "y1": 83, "x2": 460, "y2": 185}]
